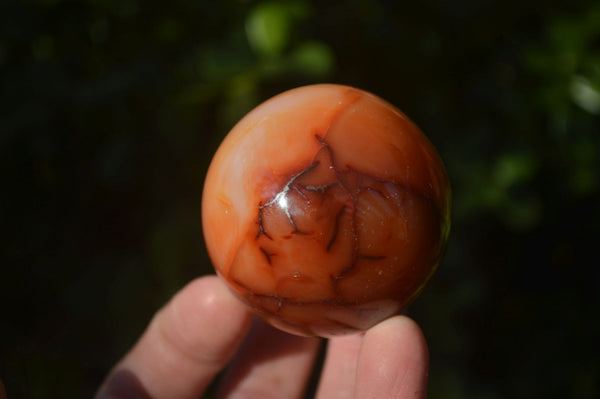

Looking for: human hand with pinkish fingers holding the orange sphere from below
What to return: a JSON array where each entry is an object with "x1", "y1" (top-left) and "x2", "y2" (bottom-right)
[{"x1": 96, "y1": 276, "x2": 428, "y2": 399}]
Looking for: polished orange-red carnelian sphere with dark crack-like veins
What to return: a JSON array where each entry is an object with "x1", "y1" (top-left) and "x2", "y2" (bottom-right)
[{"x1": 202, "y1": 85, "x2": 450, "y2": 337}]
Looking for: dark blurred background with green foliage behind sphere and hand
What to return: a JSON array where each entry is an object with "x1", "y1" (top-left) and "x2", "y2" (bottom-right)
[{"x1": 0, "y1": 0, "x2": 600, "y2": 399}]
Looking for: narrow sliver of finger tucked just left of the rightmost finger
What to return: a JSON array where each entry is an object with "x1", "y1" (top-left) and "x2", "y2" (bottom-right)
[{"x1": 317, "y1": 334, "x2": 363, "y2": 399}]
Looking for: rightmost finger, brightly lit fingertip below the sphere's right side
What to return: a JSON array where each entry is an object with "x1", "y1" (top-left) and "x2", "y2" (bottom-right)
[{"x1": 355, "y1": 316, "x2": 429, "y2": 399}]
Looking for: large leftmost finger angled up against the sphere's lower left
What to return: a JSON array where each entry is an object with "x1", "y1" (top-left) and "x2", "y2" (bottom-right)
[{"x1": 98, "y1": 276, "x2": 251, "y2": 398}]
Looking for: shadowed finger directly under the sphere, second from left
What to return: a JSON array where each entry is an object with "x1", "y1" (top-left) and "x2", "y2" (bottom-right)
[{"x1": 217, "y1": 319, "x2": 320, "y2": 399}]
